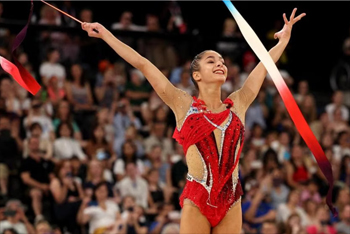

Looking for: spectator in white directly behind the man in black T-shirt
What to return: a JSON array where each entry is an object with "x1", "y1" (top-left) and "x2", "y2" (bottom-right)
[{"x1": 23, "y1": 123, "x2": 53, "y2": 160}]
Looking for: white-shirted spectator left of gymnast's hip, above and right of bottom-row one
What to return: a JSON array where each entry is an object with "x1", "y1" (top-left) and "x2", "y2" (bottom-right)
[{"x1": 115, "y1": 162, "x2": 148, "y2": 208}]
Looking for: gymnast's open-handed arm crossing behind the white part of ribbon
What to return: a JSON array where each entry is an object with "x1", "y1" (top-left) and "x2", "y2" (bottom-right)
[{"x1": 230, "y1": 8, "x2": 306, "y2": 110}]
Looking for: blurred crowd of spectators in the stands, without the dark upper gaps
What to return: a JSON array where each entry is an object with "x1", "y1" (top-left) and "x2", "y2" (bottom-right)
[{"x1": 0, "y1": 1, "x2": 350, "y2": 234}]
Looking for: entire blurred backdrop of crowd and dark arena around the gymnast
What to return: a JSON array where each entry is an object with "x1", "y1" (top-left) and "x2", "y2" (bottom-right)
[{"x1": 0, "y1": 1, "x2": 350, "y2": 234}]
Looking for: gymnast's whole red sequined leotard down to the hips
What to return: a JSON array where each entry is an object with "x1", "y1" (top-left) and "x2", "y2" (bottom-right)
[{"x1": 173, "y1": 97, "x2": 244, "y2": 227}]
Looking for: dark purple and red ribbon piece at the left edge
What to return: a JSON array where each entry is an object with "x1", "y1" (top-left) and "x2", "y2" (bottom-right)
[{"x1": 0, "y1": 1, "x2": 40, "y2": 95}]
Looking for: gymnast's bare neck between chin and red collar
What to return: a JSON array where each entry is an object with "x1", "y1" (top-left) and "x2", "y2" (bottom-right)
[{"x1": 198, "y1": 85, "x2": 222, "y2": 110}]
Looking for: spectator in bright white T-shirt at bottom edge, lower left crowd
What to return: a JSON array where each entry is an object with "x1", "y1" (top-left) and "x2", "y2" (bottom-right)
[{"x1": 77, "y1": 182, "x2": 120, "y2": 234}]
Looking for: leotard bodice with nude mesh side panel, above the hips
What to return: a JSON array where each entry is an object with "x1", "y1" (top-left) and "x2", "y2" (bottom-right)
[{"x1": 173, "y1": 99, "x2": 244, "y2": 207}]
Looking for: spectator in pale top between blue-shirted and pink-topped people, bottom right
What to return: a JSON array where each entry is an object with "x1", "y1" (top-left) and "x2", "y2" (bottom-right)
[{"x1": 276, "y1": 190, "x2": 309, "y2": 227}]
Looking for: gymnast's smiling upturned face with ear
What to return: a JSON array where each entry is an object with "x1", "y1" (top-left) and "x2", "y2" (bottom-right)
[{"x1": 193, "y1": 50, "x2": 227, "y2": 87}]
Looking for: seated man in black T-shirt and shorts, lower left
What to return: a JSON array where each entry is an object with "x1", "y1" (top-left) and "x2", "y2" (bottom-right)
[{"x1": 20, "y1": 137, "x2": 54, "y2": 221}]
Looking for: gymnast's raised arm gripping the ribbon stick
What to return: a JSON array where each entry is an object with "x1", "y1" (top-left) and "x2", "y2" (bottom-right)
[{"x1": 82, "y1": 23, "x2": 192, "y2": 114}]
